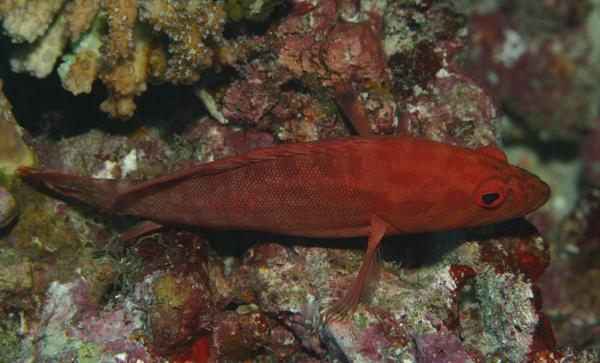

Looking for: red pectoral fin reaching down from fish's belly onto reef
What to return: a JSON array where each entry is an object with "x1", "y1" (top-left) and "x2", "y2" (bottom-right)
[{"x1": 323, "y1": 215, "x2": 393, "y2": 322}]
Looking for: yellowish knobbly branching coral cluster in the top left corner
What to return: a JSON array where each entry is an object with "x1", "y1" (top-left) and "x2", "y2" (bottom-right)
[{"x1": 0, "y1": 0, "x2": 227, "y2": 119}]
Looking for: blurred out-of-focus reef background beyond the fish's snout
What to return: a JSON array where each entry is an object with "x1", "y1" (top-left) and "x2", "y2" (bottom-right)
[{"x1": 461, "y1": 0, "x2": 600, "y2": 352}]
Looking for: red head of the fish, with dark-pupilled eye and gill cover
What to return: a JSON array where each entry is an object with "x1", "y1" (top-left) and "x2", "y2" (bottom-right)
[{"x1": 376, "y1": 143, "x2": 550, "y2": 233}]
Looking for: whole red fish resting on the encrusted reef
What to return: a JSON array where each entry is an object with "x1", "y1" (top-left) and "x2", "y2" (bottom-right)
[{"x1": 19, "y1": 136, "x2": 550, "y2": 319}]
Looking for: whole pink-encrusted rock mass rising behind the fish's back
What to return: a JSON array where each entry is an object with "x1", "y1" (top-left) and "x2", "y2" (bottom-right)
[{"x1": 221, "y1": 1, "x2": 498, "y2": 146}]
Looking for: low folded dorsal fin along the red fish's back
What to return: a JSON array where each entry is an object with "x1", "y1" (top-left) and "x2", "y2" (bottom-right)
[{"x1": 115, "y1": 136, "x2": 386, "y2": 201}]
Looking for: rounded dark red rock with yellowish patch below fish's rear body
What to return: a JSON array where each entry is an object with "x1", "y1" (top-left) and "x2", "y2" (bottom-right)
[{"x1": 128, "y1": 234, "x2": 219, "y2": 354}]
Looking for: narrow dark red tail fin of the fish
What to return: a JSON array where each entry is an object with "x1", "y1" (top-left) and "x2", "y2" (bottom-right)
[{"x1": 17, "y1": 167, "x2": 123, "y2": 211}]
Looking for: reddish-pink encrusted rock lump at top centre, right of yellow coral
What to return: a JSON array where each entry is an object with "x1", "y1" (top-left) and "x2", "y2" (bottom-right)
[{"x1": 272, "y1": 1, "x2": 385, "y2": 82}]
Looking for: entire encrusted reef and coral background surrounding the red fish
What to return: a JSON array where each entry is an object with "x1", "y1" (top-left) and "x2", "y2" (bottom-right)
[{"x1": 0, "y1": 0, "x2": 600, "y2": 363}]
